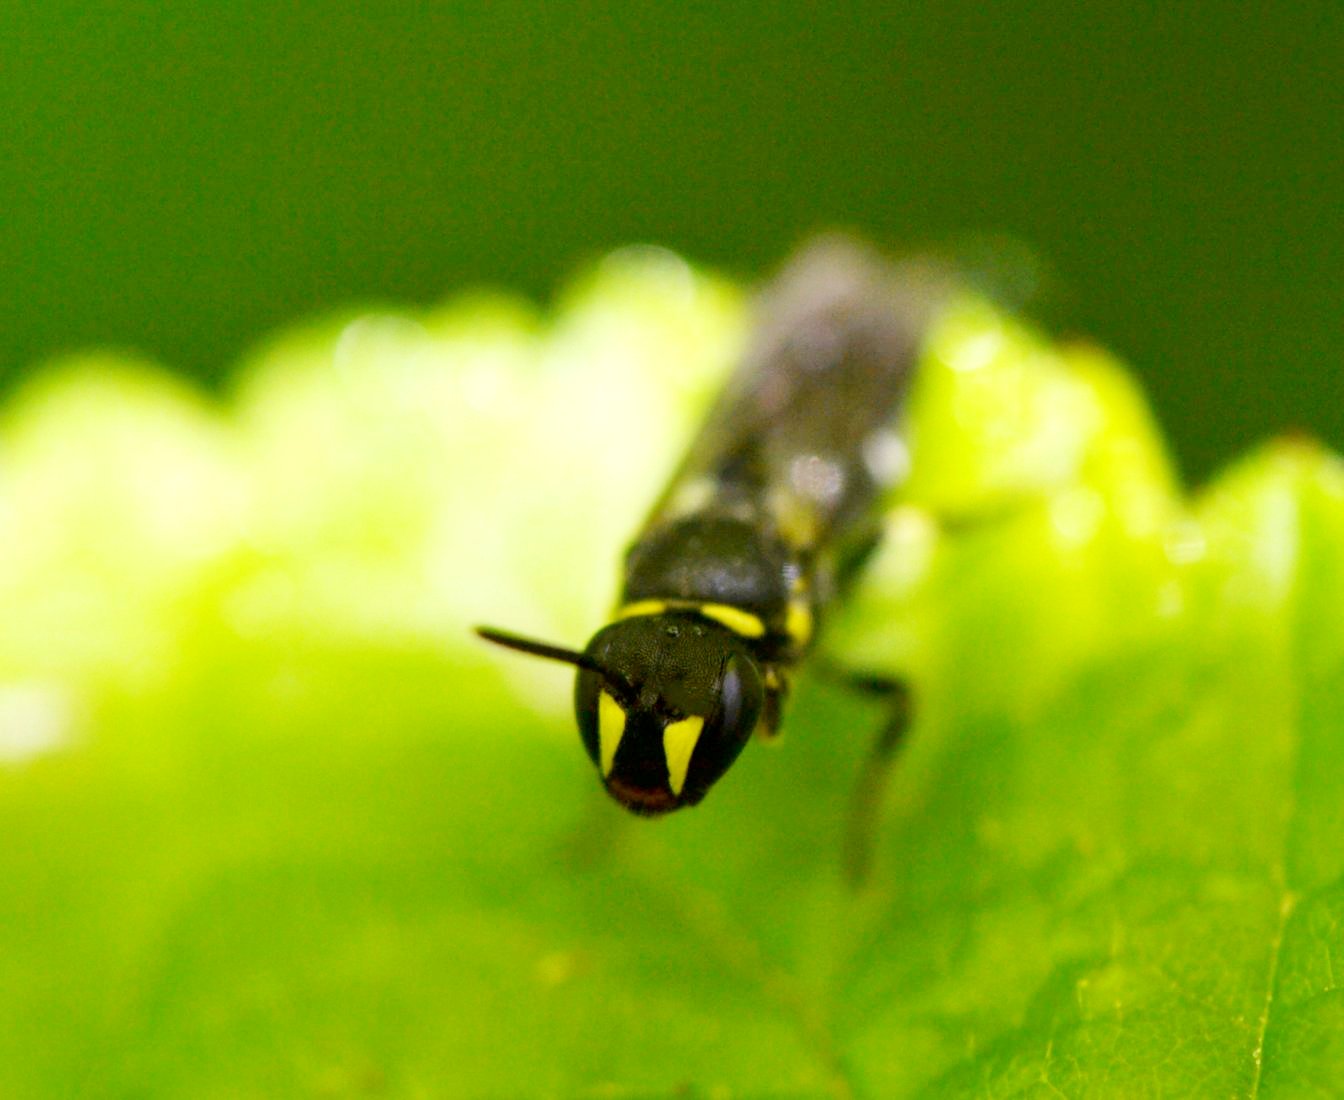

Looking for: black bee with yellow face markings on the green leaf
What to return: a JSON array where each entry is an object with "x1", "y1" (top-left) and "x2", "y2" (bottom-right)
[{"x1": 478, "y1": 237, "x2": 949, "y2": 866}]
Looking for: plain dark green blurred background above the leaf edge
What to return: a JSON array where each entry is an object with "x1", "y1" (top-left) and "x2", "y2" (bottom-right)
[{"x1": 0, "y1": 0, "x2": 1344, "y2": 477}]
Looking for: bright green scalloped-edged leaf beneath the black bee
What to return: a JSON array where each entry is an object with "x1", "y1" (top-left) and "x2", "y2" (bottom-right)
[{"x1": 0, "y1": 251, "x2": 1344, "y2": 1097}]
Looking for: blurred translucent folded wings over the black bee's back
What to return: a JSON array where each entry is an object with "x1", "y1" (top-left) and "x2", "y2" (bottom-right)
[{"x1": 649, "y1": 237, "x2": 950, "y2": 554}]
